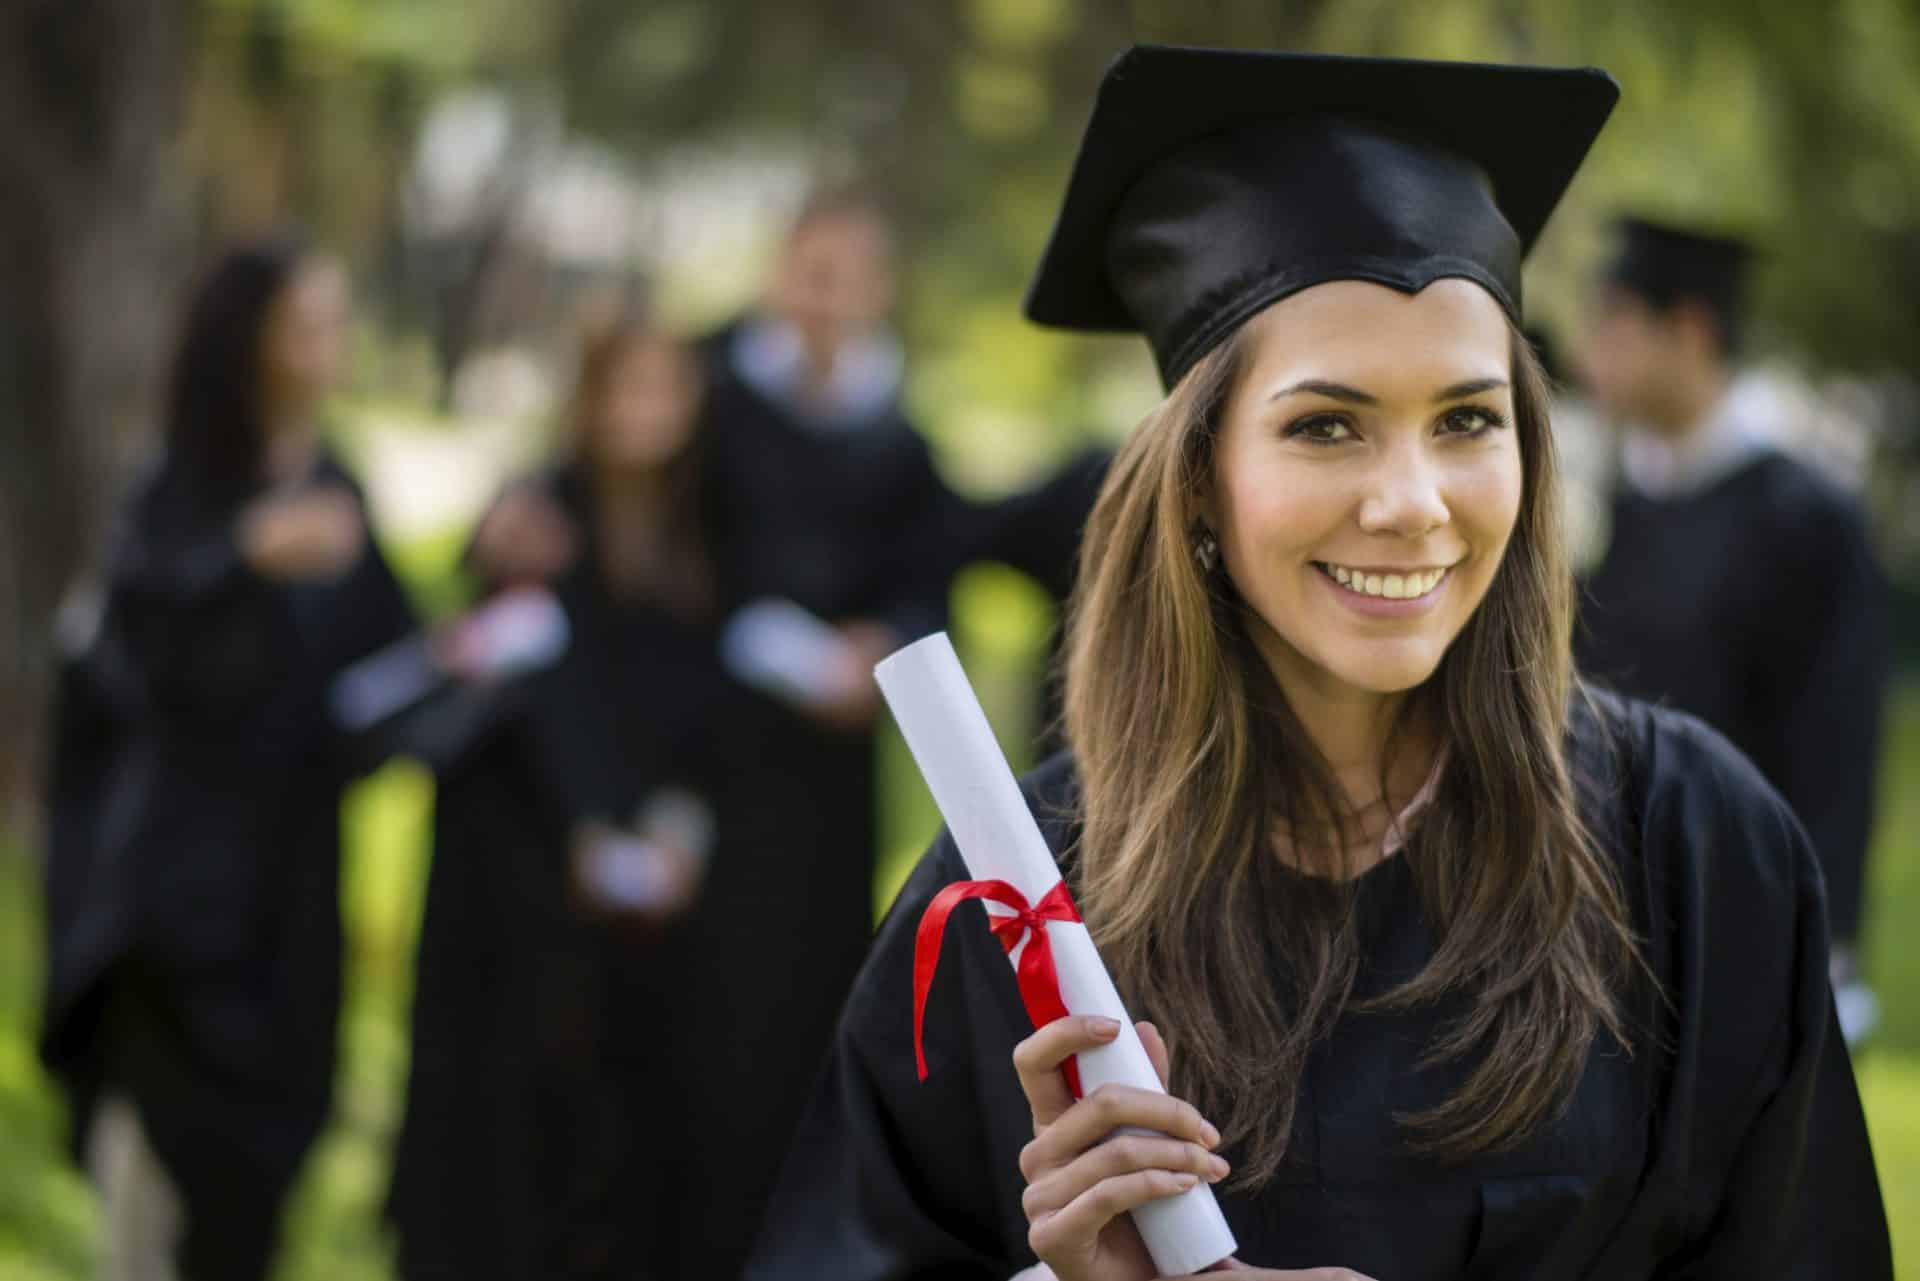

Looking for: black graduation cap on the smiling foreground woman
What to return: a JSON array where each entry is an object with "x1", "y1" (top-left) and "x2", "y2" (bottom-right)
[{"x1": 1027, "y1": 44, "x2": 1620, "y2": 386}]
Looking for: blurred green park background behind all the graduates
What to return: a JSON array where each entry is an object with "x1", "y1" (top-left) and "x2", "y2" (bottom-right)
[{"x1": 0, "y1": 0, "x2": 1920, "y2": 1281}]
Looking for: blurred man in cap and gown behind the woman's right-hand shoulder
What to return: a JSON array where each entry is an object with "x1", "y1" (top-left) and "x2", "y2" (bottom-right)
[{"x1": 1576, "y1": 217, "x2": 1891, "y2": 1039}]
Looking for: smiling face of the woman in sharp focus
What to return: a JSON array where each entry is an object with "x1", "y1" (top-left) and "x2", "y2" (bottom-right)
[{"x1": 1204, "y1": 280, "x2": 1521, "y2": 697}]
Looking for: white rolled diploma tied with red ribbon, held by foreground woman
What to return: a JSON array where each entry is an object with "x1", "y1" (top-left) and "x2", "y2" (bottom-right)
[{"x1": 874, "y1": 632, "x2": 1235, "y2": 1277}]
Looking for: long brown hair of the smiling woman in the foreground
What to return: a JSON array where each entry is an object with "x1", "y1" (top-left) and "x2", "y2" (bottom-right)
[{"x1": 1066, "y1": 318, "x2": 1636, "y2": 1187}]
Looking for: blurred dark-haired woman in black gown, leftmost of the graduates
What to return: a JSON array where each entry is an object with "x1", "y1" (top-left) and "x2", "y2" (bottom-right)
[{"x1": 42, "y1": 238, "x2": 413, "y2": 1281}]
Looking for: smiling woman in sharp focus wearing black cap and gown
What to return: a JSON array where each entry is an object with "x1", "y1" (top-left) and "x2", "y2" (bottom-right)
[{"x1": 749, "y1": 48, "x2": 1891, "y2": 1281}]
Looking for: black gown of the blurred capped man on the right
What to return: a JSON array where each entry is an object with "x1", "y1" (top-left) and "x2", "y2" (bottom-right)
[{"x1": 1576, "y1": 453, "x2": 1891, "y2": 941}]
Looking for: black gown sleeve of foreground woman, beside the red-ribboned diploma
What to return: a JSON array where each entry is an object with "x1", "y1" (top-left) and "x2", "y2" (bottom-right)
[{"x1": 747, "y1": 837, "x2": 1035, "y2": 1281}]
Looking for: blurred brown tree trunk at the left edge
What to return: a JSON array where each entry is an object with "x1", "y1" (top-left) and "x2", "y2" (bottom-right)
[{"x1": 0, "y1": 0, "x2": 194, "y2": 822}]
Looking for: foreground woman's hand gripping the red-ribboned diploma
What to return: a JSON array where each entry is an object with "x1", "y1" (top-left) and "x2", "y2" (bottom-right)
[{"x1": 1014, "y1": 1014, "x2": 1369, "y2": 1281}]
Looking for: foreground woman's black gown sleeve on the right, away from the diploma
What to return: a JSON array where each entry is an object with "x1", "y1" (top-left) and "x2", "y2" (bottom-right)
[{"x1": 1644, "y1": 713, "x2": 1893, "y2": 1281}]
